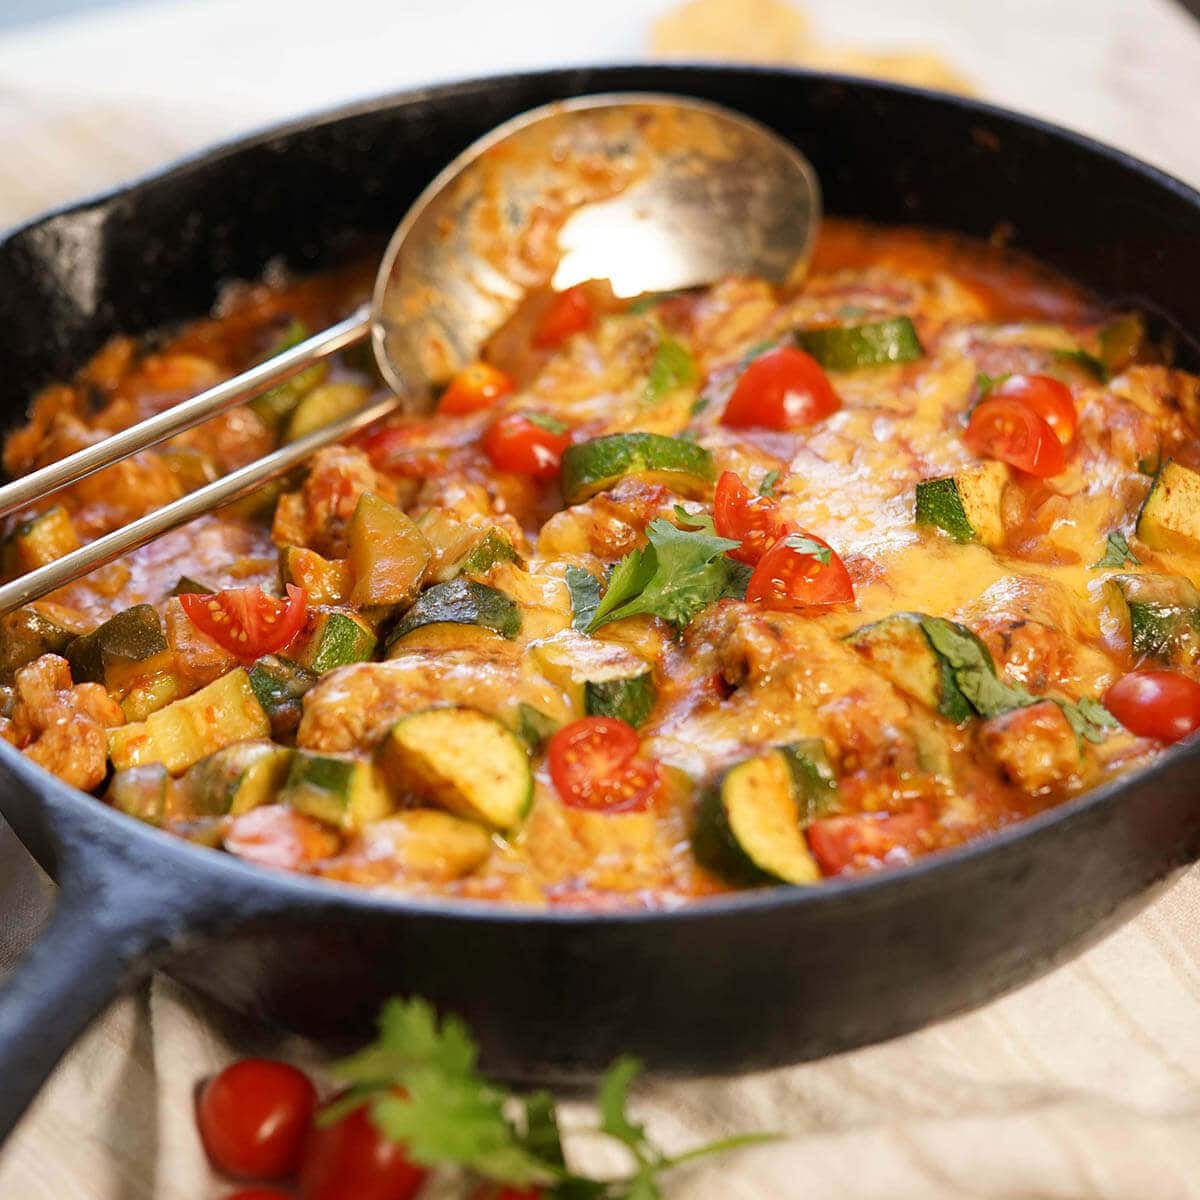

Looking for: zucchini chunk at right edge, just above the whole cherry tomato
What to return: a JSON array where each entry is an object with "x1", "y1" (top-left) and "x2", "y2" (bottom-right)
[{"x1": 1103, "y1": 575, "x2": 1200, "y2": 666}]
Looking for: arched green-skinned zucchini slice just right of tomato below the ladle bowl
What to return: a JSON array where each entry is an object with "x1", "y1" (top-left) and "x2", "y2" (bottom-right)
[{"x1": 562, "y1": 433, "x2": 714, "y2": 504}]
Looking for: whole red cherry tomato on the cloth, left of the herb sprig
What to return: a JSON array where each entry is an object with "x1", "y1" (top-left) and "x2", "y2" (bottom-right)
[{"x1": 196, "y1": 1058, "x2": 317, "y2": 1180}]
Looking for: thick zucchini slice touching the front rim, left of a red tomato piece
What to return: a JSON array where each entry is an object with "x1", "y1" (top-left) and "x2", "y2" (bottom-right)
[{"x1": 692, "y1": 738, "x2": 836, "y2": 886}]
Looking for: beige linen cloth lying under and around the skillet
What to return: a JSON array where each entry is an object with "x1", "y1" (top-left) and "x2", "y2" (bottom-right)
[{"x1": 0, "y1": 0, "x2": 1200, "y2": 1200}]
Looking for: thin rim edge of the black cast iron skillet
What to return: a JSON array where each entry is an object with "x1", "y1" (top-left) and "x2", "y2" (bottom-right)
[{"x1": 0, "y1": 60, "x2": 1200, "y2": 926}]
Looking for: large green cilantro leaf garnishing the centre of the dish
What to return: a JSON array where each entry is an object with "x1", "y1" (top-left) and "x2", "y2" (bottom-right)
[{"x1": 588, "y1": 517, "x2": 739, "y2": 632}]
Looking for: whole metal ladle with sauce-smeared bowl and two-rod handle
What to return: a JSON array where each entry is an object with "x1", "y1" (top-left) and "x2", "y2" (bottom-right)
[{"x1": 0, "y1": 94, "x2": 821, "y2": 612}]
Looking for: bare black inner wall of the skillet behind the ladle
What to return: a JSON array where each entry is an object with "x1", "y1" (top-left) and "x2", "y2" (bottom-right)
[{"x1": 0, "y1": 67, "x2": 1200, "y2": 441}]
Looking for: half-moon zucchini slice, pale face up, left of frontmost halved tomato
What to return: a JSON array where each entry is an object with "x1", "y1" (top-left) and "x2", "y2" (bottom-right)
[{"x1": 377, "y1": 708, "x2": 533, "y2": 830}]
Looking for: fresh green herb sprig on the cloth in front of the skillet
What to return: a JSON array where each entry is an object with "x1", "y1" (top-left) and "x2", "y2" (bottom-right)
[{"x1": 318, "y1": 1000, "x2": 779, "y2": 1200}]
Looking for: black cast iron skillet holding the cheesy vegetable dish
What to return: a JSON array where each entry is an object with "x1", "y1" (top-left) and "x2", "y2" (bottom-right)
[{"x1": 0, "y1": 67, "x2": 1200, "y2": 1134}]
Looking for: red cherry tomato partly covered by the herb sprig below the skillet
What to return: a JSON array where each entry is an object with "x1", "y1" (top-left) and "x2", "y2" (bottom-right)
[{"x1": 300, "y1": 1105, "x2": 428, "y2": 1200}]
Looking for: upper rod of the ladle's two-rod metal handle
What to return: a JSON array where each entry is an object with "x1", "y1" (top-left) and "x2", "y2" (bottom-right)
[{"x1": 0, "y1": 305, "x2": 371, "y2": 516}]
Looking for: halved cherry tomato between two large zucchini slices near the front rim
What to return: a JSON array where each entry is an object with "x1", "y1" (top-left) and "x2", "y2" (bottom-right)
[{"x1": 547, "y1": 716, "x2": 659, "y2": 812}]
